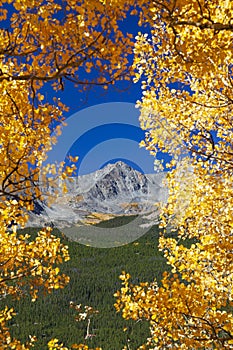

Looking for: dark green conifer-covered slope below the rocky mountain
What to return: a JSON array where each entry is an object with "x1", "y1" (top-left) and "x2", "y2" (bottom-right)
[{"x1": 1, "y1": 217, "x2": 165, "y2": 350}]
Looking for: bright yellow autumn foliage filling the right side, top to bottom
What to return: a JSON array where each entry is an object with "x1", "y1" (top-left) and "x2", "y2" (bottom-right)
[{"x1": 116, "y1": 0, "x2": 233, "y2": 349}]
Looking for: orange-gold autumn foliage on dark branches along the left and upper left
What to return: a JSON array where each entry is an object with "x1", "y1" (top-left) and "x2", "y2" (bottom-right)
[{"x1": 0, "y1": 0, "x2": 142, "y2": 349}]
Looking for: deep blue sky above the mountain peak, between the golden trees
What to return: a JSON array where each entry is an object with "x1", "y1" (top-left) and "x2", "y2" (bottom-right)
[{"x1": 45, "y1": 16, "x2": 160, "y2": 175}]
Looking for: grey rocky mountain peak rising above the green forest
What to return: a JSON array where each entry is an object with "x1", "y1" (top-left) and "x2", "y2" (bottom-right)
[{"x1": 30, "y1": 162, "x2": 167, "y2": 227}]
